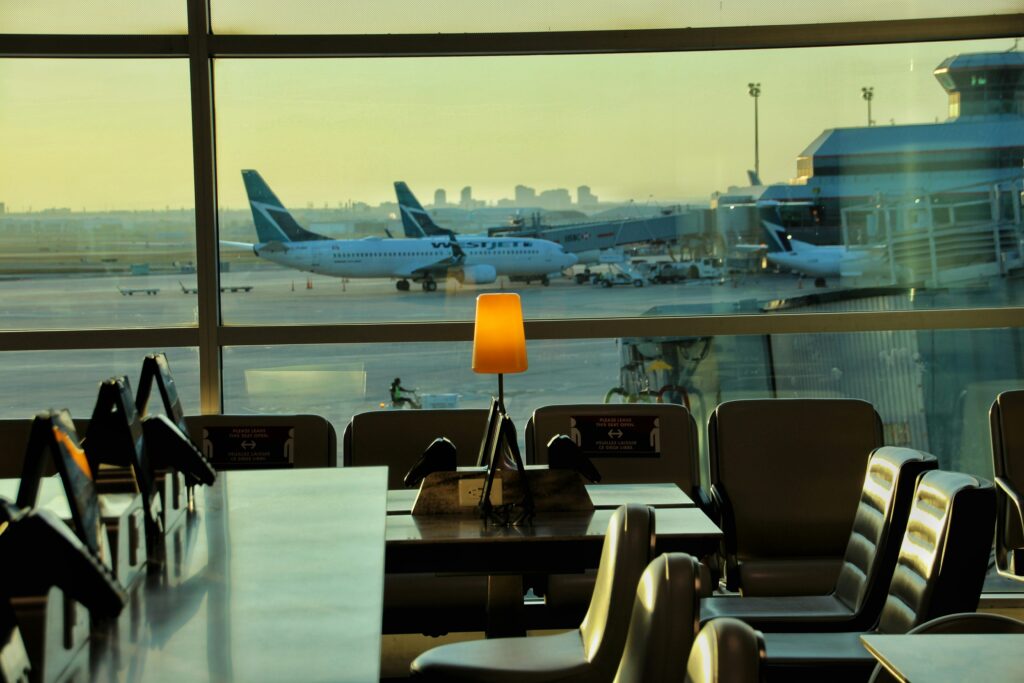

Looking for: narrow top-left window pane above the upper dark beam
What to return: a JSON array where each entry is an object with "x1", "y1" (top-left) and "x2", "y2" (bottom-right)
[{"x1": 0, "y1": 0, "x2": 188, "y2": 34}]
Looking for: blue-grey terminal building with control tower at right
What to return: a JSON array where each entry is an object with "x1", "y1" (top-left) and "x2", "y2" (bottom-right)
[{"x1": 712, "y1": 51, "x2": 1024, "y2": 284}]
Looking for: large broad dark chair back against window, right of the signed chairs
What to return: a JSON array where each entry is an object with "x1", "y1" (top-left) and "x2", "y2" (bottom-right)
[{"x1": 708, "y1": 398, "x2": 882, "y2": 596}]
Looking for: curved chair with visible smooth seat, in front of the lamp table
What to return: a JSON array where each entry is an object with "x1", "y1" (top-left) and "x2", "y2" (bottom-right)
[{"x1": 411, "y1": 505, "x2": 654, "y2": 683}]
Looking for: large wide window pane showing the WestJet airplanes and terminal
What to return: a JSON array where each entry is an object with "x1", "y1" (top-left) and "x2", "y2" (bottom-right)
[{"x1": 216, "y1": 41, "x2": 1024, "y2": 324}]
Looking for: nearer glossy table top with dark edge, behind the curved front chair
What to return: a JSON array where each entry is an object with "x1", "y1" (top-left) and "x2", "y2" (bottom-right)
[{"x1": 385, "y1": 508, "x2": 722, "y2": 573}]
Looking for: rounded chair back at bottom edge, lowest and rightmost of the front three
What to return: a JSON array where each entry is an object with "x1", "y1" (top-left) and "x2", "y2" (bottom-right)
[{"x1": 684, "y1": 616, "x2": 766, "y2": 683}]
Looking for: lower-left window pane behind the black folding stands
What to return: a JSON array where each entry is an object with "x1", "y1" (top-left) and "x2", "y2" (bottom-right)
[{"x1": 0, "y1": 347, "x2": 199, "y2": 419}]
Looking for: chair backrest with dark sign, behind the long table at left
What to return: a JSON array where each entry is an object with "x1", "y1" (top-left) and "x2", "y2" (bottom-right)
[{"x1": 185, "y1": 415, "x2": 338, "y2": 470}]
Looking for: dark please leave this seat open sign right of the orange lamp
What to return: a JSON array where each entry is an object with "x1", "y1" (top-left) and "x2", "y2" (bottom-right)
[{"x1": 569, "y1": 415, "x2": 662, "y2": 458}]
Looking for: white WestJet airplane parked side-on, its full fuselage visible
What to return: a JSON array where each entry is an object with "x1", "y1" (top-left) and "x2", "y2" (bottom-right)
[{"x1": 228, "y1": 170, "x2": 577, "y2": 292}]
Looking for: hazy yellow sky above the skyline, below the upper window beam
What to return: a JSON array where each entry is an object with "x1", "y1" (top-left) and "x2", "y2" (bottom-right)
[{"x1": 0, "y1": 36, "x2": 1013, "y2": 211}]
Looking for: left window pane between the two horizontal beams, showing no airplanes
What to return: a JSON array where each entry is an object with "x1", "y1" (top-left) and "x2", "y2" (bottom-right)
[{"x1": 0, "y1": 59, "x2": 196, "y2": 330}]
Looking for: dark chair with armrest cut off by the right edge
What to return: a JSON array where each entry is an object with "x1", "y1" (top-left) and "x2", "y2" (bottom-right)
[{"x1": 988, "y1": 391, "x2": 1024, "y2": 581}]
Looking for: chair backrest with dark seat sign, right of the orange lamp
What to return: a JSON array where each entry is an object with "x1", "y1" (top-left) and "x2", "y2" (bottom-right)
[{"x1": 526, "y1": 403, "x2": 700, "y2": 494}]
